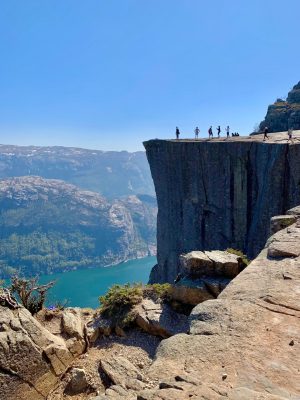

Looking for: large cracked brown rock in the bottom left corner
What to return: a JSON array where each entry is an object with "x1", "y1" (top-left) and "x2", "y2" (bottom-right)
[{"x1": 0, "y1": 306, "x2": 74, "y2": 400}]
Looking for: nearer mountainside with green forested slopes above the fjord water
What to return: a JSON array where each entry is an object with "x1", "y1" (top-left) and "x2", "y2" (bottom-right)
[{"x1": 0, "y1": 176, "x2": 157, "y2": 277}]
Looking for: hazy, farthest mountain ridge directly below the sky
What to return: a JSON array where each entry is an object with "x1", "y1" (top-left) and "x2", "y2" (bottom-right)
[{"x1": 0, "y1": 145, "x2": 155, "y2": 199}]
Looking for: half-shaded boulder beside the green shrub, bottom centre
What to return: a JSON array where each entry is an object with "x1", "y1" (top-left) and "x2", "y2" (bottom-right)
[{"x1": 134, "y1": 299, "x2": 189, "y2": 338}]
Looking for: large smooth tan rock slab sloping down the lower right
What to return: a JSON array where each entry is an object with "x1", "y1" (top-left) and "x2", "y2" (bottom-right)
[{"x1": 137, "y1": 211, "x2": 300, "y2": 400}]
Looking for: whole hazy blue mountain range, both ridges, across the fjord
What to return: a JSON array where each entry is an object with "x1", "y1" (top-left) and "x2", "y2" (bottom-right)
[{"x1": 0, "y1": 145, "x2": 157, "y2": 277}]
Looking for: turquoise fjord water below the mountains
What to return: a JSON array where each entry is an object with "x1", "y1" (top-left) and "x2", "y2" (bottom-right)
[{"x1": 40, "y1": 257, "x2": 156, "y2": 308}]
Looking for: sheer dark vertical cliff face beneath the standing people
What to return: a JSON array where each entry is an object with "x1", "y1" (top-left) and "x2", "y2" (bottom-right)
[{"x1": 144, "y1": 139, "x2": 300, "y2": 282}]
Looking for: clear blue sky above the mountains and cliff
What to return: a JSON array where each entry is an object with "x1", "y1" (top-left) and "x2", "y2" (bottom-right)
[{"x1": 0, "y1": 0, "x2": 300, "y2": 151}]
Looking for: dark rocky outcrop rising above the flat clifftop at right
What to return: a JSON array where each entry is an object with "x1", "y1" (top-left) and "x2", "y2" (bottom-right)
[{"x1": 259, "y1": 82, "x2": 300, "y2": 132}]
